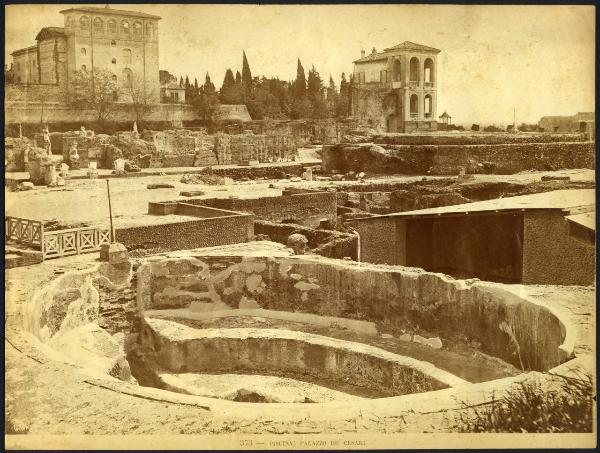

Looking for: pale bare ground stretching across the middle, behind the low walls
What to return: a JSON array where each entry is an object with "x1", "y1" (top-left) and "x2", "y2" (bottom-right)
[{"x1": 4, "y1": 170, "x2": 595, "y2": 227}]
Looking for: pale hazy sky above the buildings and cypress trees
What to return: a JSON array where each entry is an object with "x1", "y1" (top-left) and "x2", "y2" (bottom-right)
[{"x1": 5, "y1": 4, "x2": 595, "y2": 125}]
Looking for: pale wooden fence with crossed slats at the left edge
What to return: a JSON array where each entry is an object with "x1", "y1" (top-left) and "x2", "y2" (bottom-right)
[{"x1": 4, "y1": 217, "x2": 110, "y2": 259}]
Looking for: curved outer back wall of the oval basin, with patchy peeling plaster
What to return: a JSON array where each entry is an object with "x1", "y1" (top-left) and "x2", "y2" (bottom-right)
[{"x1": 137, "y1": 257, "x2": 574, "y2": 370}]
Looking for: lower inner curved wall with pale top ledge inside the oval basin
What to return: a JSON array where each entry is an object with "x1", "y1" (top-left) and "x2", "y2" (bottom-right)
[{"x1": 141, "y1": 318, "x2": 466, "y2": 397}]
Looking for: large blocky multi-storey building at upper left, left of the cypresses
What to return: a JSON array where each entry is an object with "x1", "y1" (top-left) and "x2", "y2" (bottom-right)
[{"x1": 11, "y1": 5, "x2": 161, "y2": 103}]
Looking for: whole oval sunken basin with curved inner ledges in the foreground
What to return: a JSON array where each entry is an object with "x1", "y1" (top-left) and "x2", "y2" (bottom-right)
[{"x1": 24, "y1": 247, "x2": 574, "y2": 417}]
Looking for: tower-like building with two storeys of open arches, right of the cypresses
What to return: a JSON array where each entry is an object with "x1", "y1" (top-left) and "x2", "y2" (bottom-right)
[{"x1": 352, "y1": 41, "x2": 440, "y2": 132}]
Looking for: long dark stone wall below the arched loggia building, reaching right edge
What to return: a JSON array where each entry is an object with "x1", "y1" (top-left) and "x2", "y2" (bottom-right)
[{"x1": 322, "y1": 142, "x2": 595, "y2": 175}]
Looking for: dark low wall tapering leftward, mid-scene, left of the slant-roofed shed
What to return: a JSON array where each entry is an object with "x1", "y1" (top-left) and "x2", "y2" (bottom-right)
[{"x1": 190, "y1": 192, "x2": 337, "y2": 226}]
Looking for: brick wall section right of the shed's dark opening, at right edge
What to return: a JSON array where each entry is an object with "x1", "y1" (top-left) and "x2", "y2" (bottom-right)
[{"x1": 523, "y1": 210, "x2": 596, "y2": 285}]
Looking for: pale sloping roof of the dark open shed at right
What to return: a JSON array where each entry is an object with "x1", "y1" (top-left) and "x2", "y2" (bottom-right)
[{"x1": 350, "y1": 189, "x2": 595, "y2": 222}]
